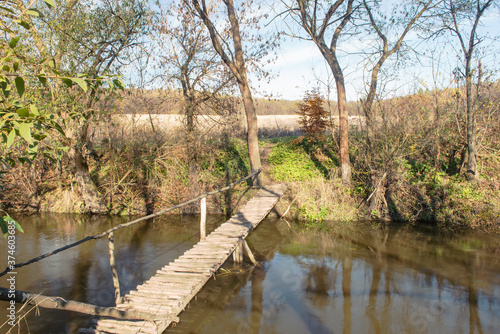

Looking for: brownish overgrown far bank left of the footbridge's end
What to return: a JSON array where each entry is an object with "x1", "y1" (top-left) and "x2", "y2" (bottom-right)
[{"x1": 0, "y1": 121, "x2": 256, "y2": 215}]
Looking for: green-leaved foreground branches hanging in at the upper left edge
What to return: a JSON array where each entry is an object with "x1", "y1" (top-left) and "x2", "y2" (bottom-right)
[{"x1": 0, "y1": 0, "x2": 123, "y2": 173}]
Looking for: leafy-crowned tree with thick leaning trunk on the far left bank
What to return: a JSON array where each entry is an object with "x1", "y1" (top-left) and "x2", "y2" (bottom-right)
[{"x1": 37, "y1": 0, "x2": 148, "y2": 212}]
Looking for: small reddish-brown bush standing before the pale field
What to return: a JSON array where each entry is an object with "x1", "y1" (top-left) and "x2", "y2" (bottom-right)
[{"x1": 297, "y1": 89, "x2": 329, "y2": 137}]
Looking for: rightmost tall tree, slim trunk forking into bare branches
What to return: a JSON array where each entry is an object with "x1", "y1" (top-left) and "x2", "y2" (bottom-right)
[{"x1": 438, "y1": 0, "x2": 495, "y2": 182}]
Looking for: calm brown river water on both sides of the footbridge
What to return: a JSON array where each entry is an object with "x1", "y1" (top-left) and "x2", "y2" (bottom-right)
[{"x1": 0, "y1": 215, "x2": 500, "y2": 334}]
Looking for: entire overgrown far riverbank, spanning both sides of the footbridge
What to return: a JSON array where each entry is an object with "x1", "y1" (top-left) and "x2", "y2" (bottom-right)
[{"x1": 0, "y1": 119, "x2": 500, "y2": 231}]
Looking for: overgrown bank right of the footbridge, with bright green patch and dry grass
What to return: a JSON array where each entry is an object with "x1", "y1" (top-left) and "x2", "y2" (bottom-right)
[{"x1": 263, "y1": 136, "x2": 500, "y2": 230}]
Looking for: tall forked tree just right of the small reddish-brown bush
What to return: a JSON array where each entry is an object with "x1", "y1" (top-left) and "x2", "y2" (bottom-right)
[{"x1": 288, "y1": 0, "x2": 356, "y2": 187}]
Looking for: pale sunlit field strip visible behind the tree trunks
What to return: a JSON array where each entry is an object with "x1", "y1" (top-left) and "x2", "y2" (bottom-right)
[{"x1": 112, "y1": 114, "x2": 364, "y2": 131}]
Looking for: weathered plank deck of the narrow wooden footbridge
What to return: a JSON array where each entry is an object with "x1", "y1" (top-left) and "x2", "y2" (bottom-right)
[{"x1": 80, "y1": 184, "x2": 287, "y2": 334}]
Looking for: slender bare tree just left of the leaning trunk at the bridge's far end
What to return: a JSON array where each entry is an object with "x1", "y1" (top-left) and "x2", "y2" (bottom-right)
[{"x1": 158, "y1": 2, "x2": 233, "y2": 198}]
